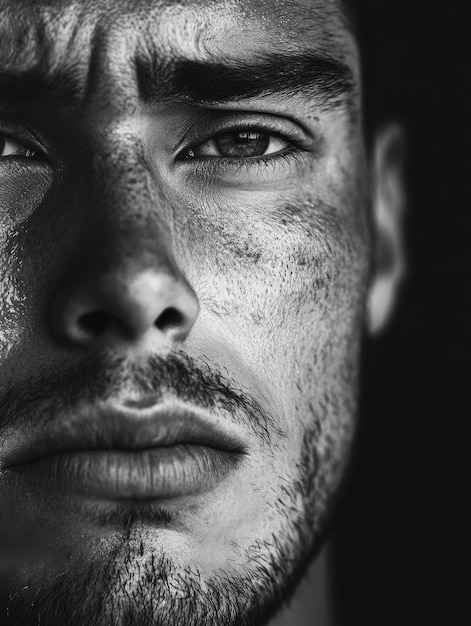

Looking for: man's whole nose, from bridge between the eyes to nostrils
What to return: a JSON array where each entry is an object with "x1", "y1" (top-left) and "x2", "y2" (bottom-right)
[{"x1": 49, "y1": 147, "x2": 199, "y2": 349}]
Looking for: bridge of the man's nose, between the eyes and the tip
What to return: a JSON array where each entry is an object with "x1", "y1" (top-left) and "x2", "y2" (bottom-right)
[{"x1": 89, "y1": 131, "x2": 176, "y2": 273}]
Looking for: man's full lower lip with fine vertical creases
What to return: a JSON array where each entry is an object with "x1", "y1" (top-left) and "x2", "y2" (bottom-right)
[{"x1": 9, "y1": 444, "x2": 240, "y2": 500}]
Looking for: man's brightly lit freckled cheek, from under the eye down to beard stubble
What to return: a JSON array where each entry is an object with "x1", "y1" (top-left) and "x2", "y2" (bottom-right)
[{"x1": 179, "y1": 189, "x2": 369, "y2": 459}]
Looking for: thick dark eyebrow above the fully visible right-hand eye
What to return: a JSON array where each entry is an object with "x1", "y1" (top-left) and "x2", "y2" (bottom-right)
[{"x1": 136, "y1": 52, "x2": 355, "y2": 106}]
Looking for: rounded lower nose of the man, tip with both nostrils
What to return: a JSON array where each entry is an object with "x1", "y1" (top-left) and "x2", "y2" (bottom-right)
[{"x1": 52, "y1": 268, "x2": 199, "y2": 348}]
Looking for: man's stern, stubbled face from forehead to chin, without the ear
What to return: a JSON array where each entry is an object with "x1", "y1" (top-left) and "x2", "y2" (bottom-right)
[{"x1": 0, "y1": 0, "x2": 376, "y2": 625}]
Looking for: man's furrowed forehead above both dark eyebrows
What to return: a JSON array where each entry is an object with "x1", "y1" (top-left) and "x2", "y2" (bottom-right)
[{"x1": 0, "y1": 0, "x2": 356, "y2": 77}]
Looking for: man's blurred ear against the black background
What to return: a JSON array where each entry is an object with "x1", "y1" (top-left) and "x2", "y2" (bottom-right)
[{"x1": 367, "y1": 125, "x2": 405, "y2": 333}]
